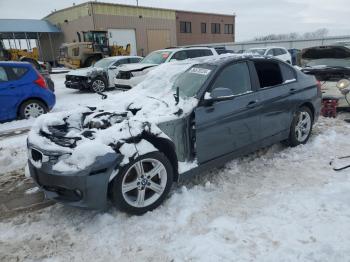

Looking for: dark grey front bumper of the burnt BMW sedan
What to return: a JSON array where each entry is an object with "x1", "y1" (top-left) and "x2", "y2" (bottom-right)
[{"x1": 28, "y1": 149, "x2": 121, "y2": 209}]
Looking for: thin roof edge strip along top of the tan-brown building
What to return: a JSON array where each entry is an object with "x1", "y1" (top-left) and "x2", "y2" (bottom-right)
[{"x1": 43, "y1": 1, "x2": 236, "y2": 19}]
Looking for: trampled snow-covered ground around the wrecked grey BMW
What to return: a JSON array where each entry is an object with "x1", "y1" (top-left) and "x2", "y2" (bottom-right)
[{"x1": 0, "y1": 72, "x2": 350, "y2": 262}]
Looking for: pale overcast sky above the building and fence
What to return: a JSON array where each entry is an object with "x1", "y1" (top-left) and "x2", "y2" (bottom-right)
[{"x1": 0, "y1": 0, "x2": 350, "y2": 41}]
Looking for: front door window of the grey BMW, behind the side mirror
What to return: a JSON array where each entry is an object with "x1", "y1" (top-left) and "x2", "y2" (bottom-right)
[{"x1": 212, "y1": 62, "x2": 252, "y2": 95}]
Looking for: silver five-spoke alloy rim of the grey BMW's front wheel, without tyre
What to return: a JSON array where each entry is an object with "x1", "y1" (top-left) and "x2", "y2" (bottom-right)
[{"x1": 122, "y1": 158, "x2": 167, "y2": 208}]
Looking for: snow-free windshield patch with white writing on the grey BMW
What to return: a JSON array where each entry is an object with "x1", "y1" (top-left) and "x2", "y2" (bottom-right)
[{"x1": 173, "y1": 64, "x2": 215, "y2": 97}]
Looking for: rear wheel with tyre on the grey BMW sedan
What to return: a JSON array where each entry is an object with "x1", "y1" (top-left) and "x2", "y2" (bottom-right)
[{"x1": 288, "y1": 107, "x2": 313, "y2": 147}]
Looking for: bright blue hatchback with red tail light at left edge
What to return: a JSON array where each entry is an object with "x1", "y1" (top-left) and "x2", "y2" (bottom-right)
[{"x1": 0, "y1": 61, "x2": 56, "y2": 121}]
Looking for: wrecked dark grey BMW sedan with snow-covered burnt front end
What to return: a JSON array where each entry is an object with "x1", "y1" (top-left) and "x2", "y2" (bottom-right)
[{"x1": 28, "y1": 56, "x2": 321, "y2": 214}]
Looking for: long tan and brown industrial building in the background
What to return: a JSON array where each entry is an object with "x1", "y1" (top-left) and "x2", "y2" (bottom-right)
[{"x1": 44, "y1": 2, "x2": 235, "y2": 55}]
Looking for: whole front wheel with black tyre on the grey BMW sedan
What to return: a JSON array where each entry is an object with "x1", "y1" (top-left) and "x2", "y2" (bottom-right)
[{"x1": 111, "y1": 152, "x2": 173, "y2": 215}]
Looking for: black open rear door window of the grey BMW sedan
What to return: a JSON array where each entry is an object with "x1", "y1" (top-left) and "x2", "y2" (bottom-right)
[{"x1": 254, "y1": 60, "x2": 284, "y2": 88}]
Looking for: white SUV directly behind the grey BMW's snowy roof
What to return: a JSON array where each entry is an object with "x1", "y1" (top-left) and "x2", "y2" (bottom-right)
[{"x1": 114, "y1": 47, "x2": 218, "y2": 89}]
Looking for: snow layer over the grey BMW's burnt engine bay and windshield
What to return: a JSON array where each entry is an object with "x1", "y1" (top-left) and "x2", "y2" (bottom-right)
[{"x1": 28, "y1": 61, "x2": 198, "y2": 171}]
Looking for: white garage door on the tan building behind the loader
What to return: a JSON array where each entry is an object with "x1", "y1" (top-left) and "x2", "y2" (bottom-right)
[{"x1": 108, "y1": 29, "x2": 137, "y2": 55}]
